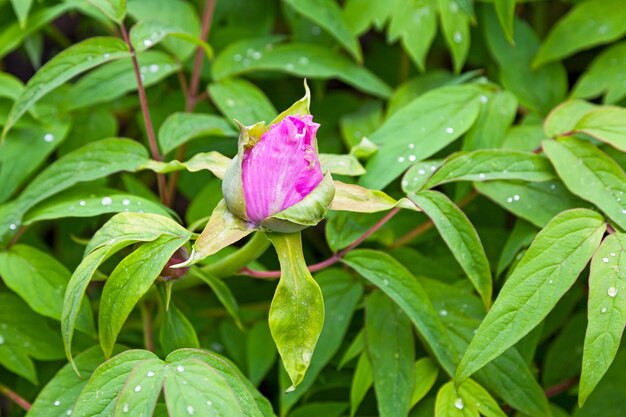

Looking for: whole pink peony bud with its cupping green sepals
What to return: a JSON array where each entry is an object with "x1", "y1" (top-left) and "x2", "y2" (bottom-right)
[{"x1": 222, "y1": 115, "x2": 335, "y2": 233}]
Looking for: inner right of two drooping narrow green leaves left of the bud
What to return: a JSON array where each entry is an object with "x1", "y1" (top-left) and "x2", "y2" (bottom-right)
[{"x1": 98, "y1": 234, "x2": 190, "y2": 358}]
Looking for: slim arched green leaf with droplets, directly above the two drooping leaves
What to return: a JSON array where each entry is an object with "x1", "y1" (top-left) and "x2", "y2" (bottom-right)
[{"x1": 24, "y1": 186, "x2": 171, "y2": 226}]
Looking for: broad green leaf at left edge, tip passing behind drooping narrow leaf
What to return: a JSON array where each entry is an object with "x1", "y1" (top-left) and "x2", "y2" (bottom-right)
[{"x1": 0, "y1": 244, "x2": 95, "y2": 335}]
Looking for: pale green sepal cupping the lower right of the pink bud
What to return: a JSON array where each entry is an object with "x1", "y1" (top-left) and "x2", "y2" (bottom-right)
[{"x1": 261, "y1": 172, "x2": 335, "y2": 233}]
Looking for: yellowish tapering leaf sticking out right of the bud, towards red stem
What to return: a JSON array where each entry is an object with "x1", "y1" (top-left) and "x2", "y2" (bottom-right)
[{"x1": 330, "y1": 181, "x2": 416, "y2": 213}]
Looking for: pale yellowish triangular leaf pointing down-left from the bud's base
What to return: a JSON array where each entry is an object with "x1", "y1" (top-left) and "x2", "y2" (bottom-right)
[{"x1": 175, "y1": 200, "x2": 255, "y2": 268}]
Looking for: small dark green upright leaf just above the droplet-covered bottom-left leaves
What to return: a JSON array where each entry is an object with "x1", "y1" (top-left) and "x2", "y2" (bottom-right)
[{"x1": 159, "y1": 303, "x2": 200, "y2": 355}]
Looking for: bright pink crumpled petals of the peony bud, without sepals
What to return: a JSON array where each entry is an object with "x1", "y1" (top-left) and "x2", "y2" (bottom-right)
[{"x1": 242, "y1": 115, "x2": 323, "y2": 223}]
